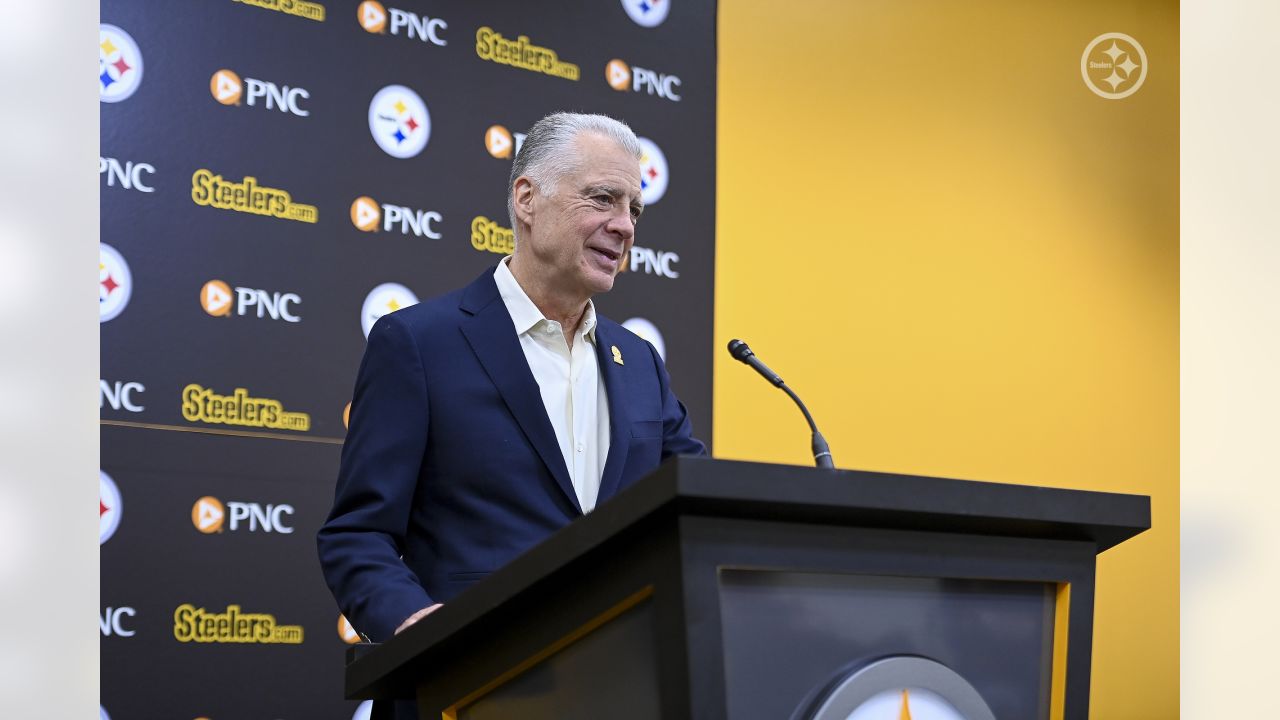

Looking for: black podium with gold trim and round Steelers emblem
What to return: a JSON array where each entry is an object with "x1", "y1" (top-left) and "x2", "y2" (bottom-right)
[{"x1": 346, "y1": 457, "x2": 1151, "y2": 720}]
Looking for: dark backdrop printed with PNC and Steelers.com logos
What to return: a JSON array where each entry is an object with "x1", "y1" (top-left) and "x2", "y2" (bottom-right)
[{"x1": 99, "y1": 0, "x2": 716, "y2": 720}]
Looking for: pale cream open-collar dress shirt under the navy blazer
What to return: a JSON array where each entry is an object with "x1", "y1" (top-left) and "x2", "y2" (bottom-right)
[{"x1": 493, "y1": 255, "x2": 609, "y2": 512}]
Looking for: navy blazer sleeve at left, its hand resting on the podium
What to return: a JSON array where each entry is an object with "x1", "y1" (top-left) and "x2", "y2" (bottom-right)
[{"x1": 316, "y1": 314, "x2": 433, "y2": 642}]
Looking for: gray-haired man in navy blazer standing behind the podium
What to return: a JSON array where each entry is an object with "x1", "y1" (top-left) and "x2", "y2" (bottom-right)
[{"x1": 317, "y1": 113, "x2": 707, "y2": 653}]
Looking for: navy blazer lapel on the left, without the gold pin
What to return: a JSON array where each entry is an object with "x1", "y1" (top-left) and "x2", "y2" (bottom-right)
[{"x1": 461, "y1": 269, "x2": 581, "y2": 514}]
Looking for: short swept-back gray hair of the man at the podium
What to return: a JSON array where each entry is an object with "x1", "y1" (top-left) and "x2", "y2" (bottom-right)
[{"x1": 507, "y1": 113, "x2": 644, "y2": 233}]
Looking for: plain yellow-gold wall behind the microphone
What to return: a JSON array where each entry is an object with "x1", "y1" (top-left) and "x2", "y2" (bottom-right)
[{"x1": 713, "y1": 0, "x2": 1179, "y2": 720}]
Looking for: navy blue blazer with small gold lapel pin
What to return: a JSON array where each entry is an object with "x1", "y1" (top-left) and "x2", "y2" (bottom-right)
[{"x1": 317, "y1": 269, "x2": 707, "y2": 642}]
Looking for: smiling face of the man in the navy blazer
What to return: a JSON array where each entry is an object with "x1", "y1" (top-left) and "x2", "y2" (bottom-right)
[{"x1": 527, "y1": 133, "x2": 641, "y2": 296}]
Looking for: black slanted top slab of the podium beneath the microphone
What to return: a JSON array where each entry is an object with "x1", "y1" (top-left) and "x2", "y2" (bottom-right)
[{"x1": 346, "y1": 456, "x2": 1151, "y2": 698}]
